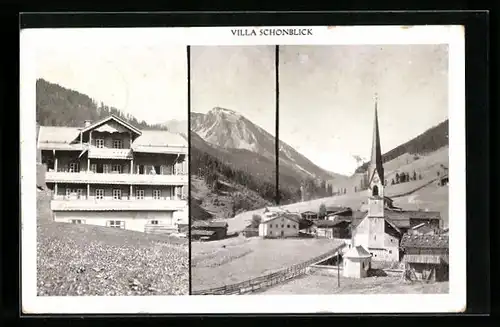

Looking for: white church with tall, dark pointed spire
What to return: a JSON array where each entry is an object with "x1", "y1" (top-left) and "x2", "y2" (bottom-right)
[{"x1": 351, "y1": 95, "x2": 441, "y2": 262}]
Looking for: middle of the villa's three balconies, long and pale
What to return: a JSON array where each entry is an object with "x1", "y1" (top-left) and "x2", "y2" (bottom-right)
[{"x1": 45, "y1": 171, "x2": 188, "y2": 186}]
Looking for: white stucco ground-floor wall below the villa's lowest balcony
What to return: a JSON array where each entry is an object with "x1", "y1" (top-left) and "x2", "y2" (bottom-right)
[{"x1": 54, "y1": 211, "x2": 175, "y2": 232}]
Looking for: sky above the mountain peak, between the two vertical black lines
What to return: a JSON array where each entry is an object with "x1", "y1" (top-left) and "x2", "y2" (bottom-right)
[{"x1": 191, "y1": 46, "x2": 276, "y2": 135}]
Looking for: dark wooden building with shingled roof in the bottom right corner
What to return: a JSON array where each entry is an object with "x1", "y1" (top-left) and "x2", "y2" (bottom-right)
[{"x1": 401, "y1": 234, "x2": 449, "y2": 281}]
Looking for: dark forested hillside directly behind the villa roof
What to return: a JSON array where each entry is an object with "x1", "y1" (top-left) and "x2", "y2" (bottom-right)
[{"x1": 36, "y1": 79, "x2": 167, "y2": 130}]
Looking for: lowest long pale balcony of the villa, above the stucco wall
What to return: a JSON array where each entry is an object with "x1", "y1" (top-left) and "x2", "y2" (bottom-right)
[{"x1": 50, "y1": 199, "x2": 187, "y2": 211}]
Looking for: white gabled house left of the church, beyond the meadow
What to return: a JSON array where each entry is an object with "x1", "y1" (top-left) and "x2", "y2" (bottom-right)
[{"x1": 259, "y1": 213, "x2": 300, "y2": 238}]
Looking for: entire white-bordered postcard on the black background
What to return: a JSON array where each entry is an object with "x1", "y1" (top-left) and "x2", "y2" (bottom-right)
[{"x1": 21, "y1": 25, "x2": 466, "y2": 314}]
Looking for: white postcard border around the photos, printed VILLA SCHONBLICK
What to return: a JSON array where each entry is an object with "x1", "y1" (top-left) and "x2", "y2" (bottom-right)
[{"x1": 20, "y1": 26, "x2": 466, "y2": 314}]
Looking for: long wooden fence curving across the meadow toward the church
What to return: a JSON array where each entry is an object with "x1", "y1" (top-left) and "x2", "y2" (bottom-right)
[{"x1": 191, "y1": 244, "x2": 346, "y2": 295}]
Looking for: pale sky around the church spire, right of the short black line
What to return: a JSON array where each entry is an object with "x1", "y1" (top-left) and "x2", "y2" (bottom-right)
[{"x1": 279, "y1": 45, "x2": 448, "y2": 175}]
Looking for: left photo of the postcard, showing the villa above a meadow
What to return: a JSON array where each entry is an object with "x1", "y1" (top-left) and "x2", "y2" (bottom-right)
[{"x1": 25, "y1": 29, "x2": 189, "y2": 296}]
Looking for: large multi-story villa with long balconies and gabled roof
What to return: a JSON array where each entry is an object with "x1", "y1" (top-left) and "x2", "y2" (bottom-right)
[{"x1": 38, "y1": 116, "x2": 188, "y2": 232}]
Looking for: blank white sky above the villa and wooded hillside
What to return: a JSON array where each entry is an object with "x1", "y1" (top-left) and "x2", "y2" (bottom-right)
[{"x1": 35, "y1": 29, "x2": 188, "y2": 124}]
